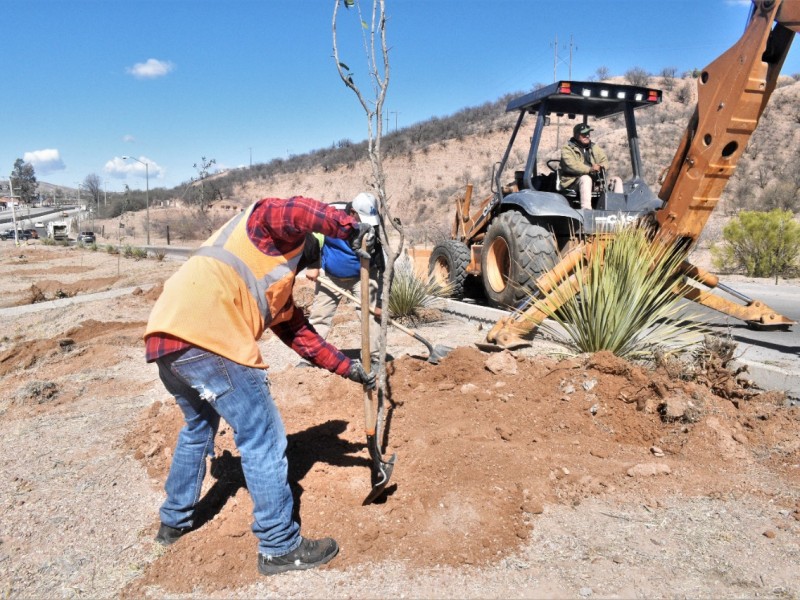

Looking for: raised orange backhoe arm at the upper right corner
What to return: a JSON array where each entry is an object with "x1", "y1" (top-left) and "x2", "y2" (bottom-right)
[{"x1": 656, "y1": 0, "x2": 800, "y2": 245}]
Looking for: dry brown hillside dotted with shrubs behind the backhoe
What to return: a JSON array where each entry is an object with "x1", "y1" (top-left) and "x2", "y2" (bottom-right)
[{"x1": 209, "y1": 77, "x2": 800, "y2": 248}]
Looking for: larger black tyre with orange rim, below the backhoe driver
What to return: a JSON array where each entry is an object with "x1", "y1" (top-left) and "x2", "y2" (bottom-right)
[{"x1": 481, "y1": 211, "x2": 558, "y2": 308}]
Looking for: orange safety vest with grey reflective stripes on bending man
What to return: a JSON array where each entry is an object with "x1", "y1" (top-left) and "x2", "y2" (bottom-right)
[{"x1": 145, "y1": 204, "x2": 304, "y2": 368}]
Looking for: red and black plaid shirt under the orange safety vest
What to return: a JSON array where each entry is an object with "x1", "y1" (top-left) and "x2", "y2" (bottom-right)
[{"x1": 145, "y1": 196, "x2": 357, "y2": 375}]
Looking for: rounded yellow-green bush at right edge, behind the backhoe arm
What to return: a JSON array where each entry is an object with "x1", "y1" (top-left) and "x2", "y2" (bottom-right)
[{"x1": 711, "y1": 208, "x2": 800, "y2": 283}]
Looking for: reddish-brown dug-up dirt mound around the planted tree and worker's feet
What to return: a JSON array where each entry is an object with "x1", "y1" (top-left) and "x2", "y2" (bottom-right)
[{"x1": 120, "y1": 347, "x2": 800, "y2": 596}]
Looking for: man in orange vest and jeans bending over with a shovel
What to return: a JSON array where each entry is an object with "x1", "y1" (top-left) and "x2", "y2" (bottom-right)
[{"x1": 145, "y1": 196, "x2": 375, "y2": 575}]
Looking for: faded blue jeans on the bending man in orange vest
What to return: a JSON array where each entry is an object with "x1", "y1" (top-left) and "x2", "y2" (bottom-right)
[{"x1": 156, "y1": 348, "x2": 301, "y2": 556}]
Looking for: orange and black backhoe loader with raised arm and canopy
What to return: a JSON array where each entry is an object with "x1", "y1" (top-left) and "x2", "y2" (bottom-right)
[{"x1": 428, "y1": 0, "x2": 800, "y2": 347}]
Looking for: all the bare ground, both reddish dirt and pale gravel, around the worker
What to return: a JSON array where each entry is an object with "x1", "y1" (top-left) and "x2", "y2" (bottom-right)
[{"x1": 0, "y1": 247, "x2": 800, "y2": 598}]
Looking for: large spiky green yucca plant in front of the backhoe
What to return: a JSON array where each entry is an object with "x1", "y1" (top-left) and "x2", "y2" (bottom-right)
[{"x1": 538, "y1": 225, "x2": 704, "y2": 361}]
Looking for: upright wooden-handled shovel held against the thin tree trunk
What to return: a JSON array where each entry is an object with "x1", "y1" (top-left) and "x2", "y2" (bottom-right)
[{"x1": 361, "y1": 246, "x2": 397, "y2": 506}]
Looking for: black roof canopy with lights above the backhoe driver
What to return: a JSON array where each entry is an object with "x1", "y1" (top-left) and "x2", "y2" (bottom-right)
[{"x1": 506, "y1": 81, "x2": 661, "y2": 119}]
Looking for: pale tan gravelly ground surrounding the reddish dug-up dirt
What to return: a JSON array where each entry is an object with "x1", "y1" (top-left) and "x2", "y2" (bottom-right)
[{"x1": 0, "y1": 245, "x2": 800, "y2": 598}]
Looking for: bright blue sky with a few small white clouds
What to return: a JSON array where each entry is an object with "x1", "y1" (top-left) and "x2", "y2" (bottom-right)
[{"x1": 0, "y1": 0, "x2": 800, "y2": 191}]
